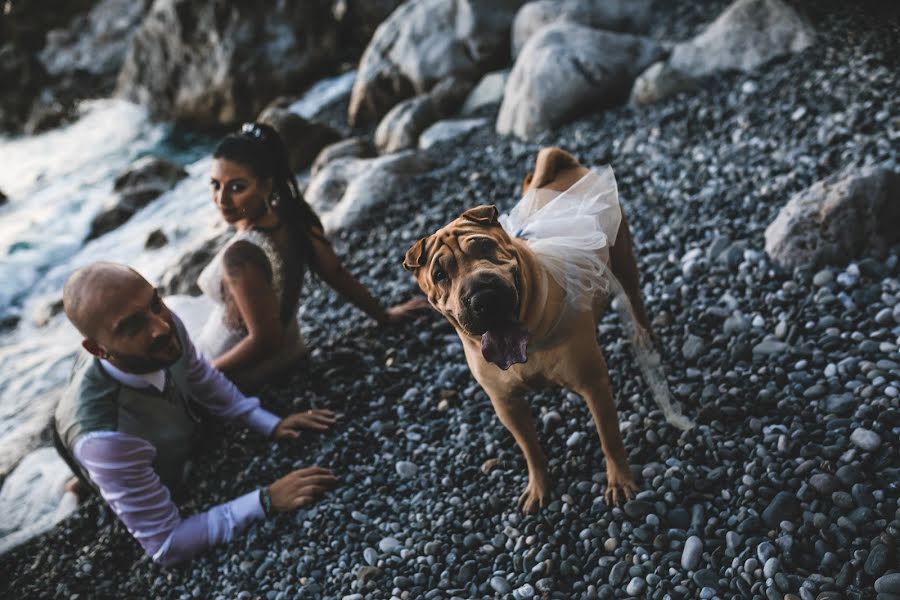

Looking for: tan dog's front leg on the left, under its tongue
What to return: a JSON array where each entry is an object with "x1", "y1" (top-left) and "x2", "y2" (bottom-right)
[{"x1": 482, "y1": 385, "x2": 550, "y2": 513}]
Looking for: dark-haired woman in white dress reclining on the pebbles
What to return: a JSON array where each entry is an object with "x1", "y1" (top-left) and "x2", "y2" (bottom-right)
[{"x1": 165, "y1": 123, "x2": 427, "y2": 389}]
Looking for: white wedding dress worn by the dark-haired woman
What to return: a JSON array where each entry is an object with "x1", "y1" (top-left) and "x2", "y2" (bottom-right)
[{"x1": 164, "y1": 230, "x2": 307, "y2": 383}]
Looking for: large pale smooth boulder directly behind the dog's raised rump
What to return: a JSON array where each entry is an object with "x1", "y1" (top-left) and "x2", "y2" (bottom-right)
[{"x1": 497, "y1": 23, "x2": 664, "y2": 139}]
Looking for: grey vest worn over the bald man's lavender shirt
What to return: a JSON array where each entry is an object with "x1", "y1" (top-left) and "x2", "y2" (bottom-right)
[{"x1": 56, "y1": 319, "x2": 198, "y2": 490}]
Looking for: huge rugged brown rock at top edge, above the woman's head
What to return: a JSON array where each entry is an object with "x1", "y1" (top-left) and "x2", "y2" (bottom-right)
[{"x1": 118, "y1": 0, "x2": 340, "y2": 127}]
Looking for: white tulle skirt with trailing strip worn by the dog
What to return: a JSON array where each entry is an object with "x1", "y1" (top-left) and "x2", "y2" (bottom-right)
[{"x1": 496, "y1": 166, "x2": 693, "y2": 430}]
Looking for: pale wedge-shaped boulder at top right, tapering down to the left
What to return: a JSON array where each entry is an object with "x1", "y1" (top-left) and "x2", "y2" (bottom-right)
[{"x1": 632, "y1": 0, "x2": 815, "y2": 104}]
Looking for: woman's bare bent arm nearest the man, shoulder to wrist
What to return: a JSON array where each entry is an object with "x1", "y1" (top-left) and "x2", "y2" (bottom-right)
[{"x1": 212, "y1": 241, "x2": 283, "y2": 374}]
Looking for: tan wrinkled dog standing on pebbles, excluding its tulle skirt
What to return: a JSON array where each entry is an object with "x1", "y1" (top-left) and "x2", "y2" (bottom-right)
[{"x1": 403, "y1": 148, "x2": 664, "y2": 512}]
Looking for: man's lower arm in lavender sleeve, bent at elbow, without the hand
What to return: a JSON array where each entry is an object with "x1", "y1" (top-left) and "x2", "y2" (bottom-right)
[{"x1": 73, "y1": 431, "x2": 265, "y2": 566}]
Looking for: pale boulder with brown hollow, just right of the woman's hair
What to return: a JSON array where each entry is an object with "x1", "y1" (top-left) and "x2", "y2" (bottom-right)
[{"x1": 305, "y1": 150, "x2": 431, "y2": 232}]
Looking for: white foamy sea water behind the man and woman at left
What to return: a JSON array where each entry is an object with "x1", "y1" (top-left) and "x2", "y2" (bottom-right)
[{"x1": 0, "y1": 73, "x2": 353, "y2": 553}]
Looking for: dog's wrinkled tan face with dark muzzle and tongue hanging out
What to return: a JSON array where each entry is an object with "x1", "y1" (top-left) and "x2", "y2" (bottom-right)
[{"x1": 403, "y1": 206, "x2": 528, "y2": 369}]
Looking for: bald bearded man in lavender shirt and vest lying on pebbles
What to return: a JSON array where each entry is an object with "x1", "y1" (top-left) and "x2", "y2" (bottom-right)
[{"x1": 54, "y1": 263, "x2": 336, "y2": 565}]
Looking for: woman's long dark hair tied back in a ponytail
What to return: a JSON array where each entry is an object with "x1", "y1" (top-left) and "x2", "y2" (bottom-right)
[{"x1": 213, "y1": 123, "x2": 324, "y2": 270}]
